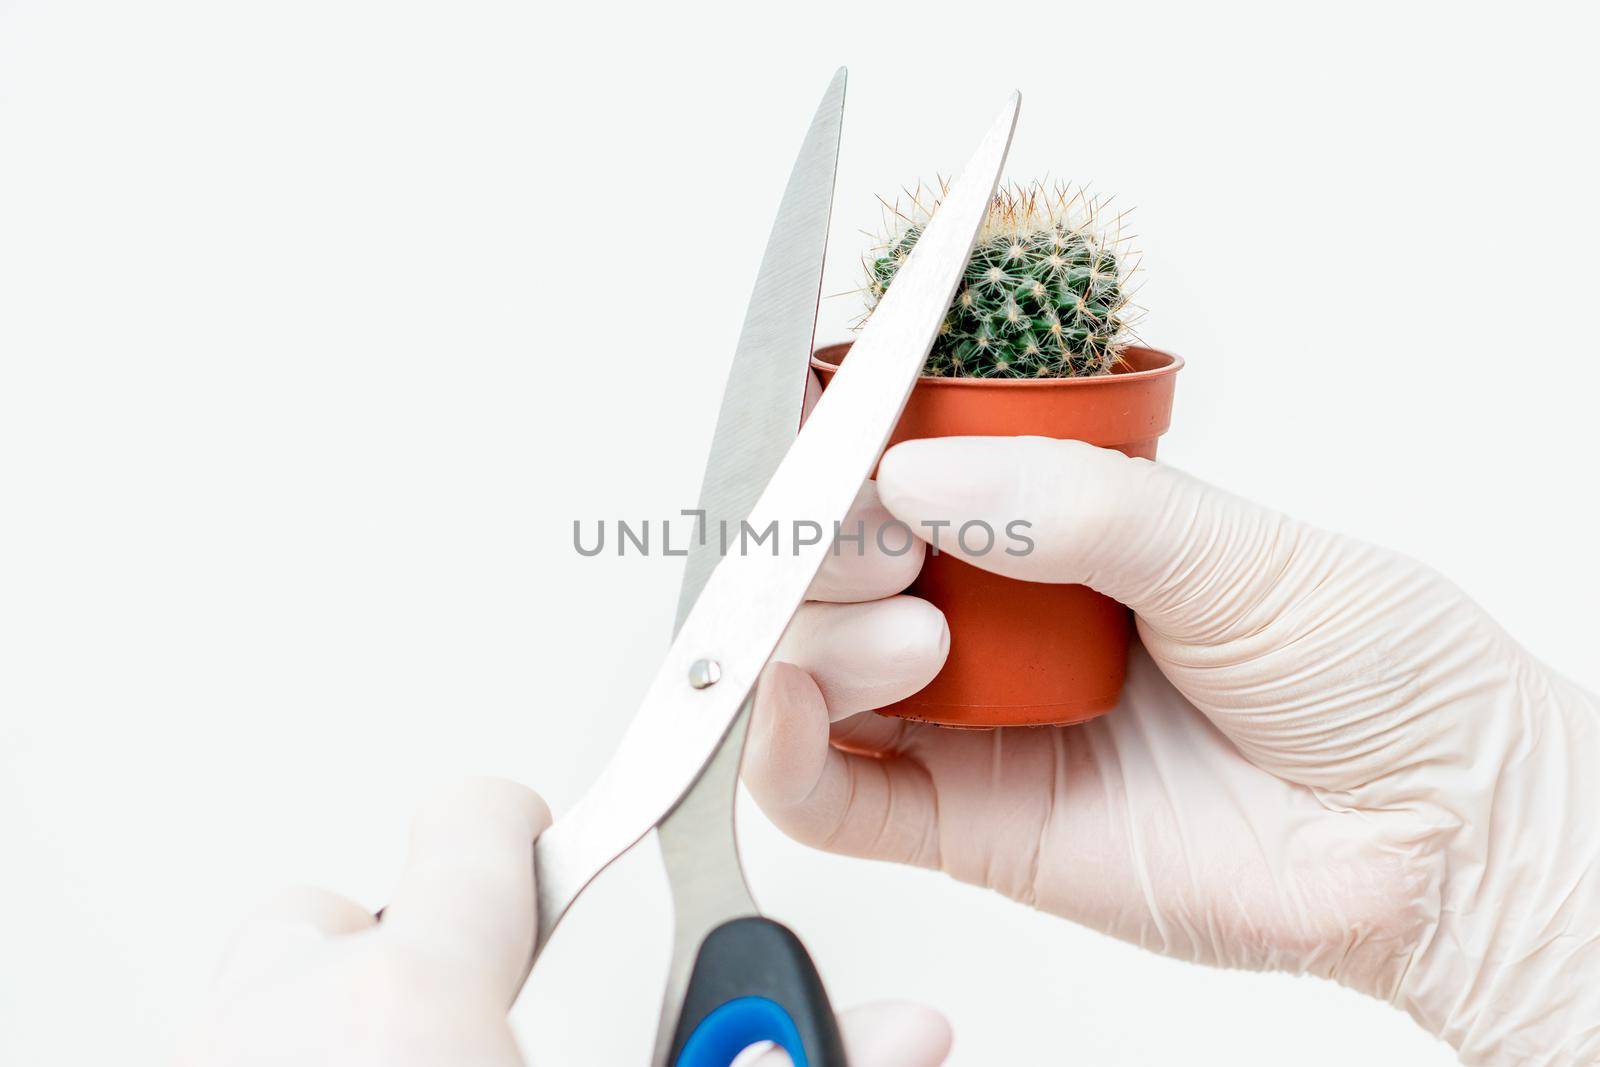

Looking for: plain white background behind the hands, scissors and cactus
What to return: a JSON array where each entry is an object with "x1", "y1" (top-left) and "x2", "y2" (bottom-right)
[{"x1": 0, "y1": 0, "x2": 1600, "y2": 1067}]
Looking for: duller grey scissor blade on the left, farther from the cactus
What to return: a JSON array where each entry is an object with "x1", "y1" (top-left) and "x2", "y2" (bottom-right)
[{"x1": 677, "y1": 67, "x2": 845, "y2": 625}]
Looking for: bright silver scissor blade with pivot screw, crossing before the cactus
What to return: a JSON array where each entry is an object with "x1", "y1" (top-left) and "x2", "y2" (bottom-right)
[{"x1": 534, "y1": 94, "x2": 1021, "y2": 953}]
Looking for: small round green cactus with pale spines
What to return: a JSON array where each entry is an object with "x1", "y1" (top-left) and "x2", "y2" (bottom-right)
[{"x1": 862, "y1": 182, "x2": 1136, "y2": 378}]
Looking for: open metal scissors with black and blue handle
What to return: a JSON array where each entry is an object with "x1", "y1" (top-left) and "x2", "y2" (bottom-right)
[{"x1": 528, "y1": 69, "x2": 1021, "y2": 1067}]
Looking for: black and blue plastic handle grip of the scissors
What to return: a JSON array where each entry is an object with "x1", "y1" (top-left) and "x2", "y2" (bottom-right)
[{"x1": 667, "y1": 915, "x2": 848, "y2": 1067}]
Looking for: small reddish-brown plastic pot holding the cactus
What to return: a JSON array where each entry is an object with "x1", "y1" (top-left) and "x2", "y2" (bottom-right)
[{"x1": 811, "y1": 344, "x2": 1184, "y2": 728}]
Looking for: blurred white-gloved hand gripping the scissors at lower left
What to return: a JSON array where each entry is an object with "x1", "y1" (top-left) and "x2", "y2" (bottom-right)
[{"x1": 182, "y1": 779, "x2": 950, "y2": 1067}]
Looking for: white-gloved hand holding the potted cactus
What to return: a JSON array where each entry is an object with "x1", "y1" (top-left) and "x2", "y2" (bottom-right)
[{"x1": 746, "y1": 438, "x2": 1600, "y2": 1064}]
